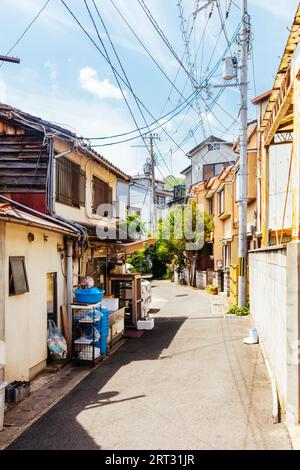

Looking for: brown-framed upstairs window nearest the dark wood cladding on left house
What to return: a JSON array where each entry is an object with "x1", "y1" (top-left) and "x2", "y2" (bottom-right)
[{"x1": 56, "y1": 157, "x2": 85, "y2": 207}]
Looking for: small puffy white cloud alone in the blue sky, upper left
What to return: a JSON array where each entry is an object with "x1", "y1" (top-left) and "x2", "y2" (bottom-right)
[{"x1": 79, "y1": 67, "x2": 122, "y2": 100}]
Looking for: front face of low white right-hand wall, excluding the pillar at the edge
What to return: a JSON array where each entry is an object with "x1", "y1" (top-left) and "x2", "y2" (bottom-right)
[{"x1": 249, "y1": 248, "x2": 288, "y2": 407}]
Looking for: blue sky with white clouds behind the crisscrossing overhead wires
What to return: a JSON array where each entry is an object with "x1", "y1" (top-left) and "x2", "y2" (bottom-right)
[{"x1": 0, "y1": 0, "x2": 298, "y2": 177}]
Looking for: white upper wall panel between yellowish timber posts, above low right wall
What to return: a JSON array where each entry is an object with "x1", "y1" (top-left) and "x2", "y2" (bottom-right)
[{"x1": 269, "y1": 144, "x2": 292, "y2": 230}]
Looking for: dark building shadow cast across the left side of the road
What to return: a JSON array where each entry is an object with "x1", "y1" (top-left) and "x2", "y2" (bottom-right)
[{"x1": 8, "y1": 317, "x2": 187, "y2": 450}]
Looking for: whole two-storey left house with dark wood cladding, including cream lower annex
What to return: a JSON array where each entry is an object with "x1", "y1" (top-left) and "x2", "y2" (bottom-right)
[{"x1": 0, "y1": 104, "x2": 150, "y2": 380}]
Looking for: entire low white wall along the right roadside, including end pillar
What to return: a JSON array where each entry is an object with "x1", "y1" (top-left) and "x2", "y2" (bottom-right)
[{"x1": 249, "y1": 242, "x2": 300, "y2": 423}]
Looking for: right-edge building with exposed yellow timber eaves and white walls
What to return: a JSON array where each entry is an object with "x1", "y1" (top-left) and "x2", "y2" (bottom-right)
[{"x1": 249, "y1": 2, "x2": 300, "y2": 424}]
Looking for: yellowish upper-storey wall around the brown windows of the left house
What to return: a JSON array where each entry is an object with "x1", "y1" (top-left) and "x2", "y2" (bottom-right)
[{"x1": 55, "y1": 139, "x2": 117, "y2": 224}]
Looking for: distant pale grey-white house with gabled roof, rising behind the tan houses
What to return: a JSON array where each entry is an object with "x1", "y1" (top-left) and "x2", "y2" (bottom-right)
[{"x1": 181, "y1": 135, "x2": 236, "y2": 193}]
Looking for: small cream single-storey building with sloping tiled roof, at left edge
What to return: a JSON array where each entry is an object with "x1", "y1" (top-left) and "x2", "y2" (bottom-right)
[{"x1": 0, "y1": 200, "x2": 80, "y2": 382}]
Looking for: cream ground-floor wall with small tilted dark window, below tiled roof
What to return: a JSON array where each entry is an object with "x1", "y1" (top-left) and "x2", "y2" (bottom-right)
[{"x1": 4, "y1": 223, "x2": 65, "y2": 382}]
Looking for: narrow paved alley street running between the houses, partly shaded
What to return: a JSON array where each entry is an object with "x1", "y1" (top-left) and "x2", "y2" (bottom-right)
[{"x1": 9, "y1": 281, "x2": 291, "y2": 450}]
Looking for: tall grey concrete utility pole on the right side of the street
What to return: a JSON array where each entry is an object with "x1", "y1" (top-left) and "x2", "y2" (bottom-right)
[{"x1": 238, "y1": 0, "x2": 250, "y2": 307}]
